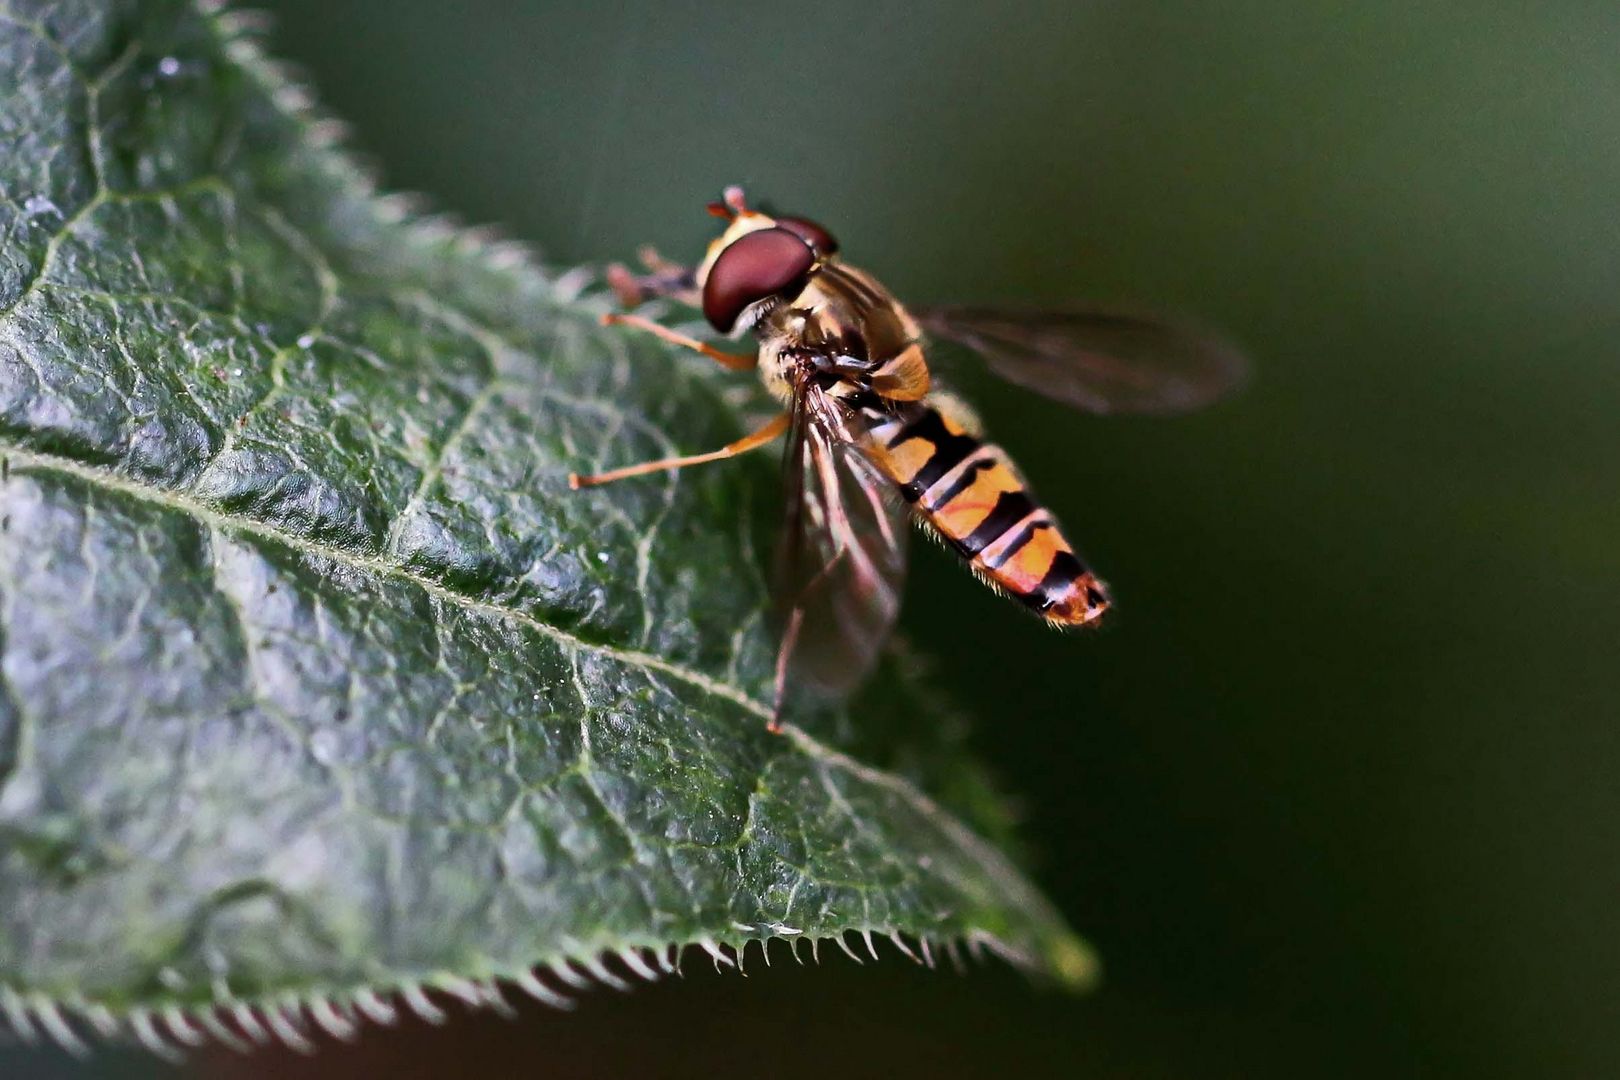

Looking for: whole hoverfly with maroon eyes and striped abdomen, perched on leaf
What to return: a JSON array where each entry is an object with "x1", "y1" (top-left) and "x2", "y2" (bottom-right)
[{"x1": 569, "y1": 186, "x2": 1244, "y2": 730}]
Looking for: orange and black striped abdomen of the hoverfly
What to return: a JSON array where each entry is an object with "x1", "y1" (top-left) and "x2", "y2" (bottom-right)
[{"x1": 870, "y1": 403, "x2": 1108, "y2": 625}]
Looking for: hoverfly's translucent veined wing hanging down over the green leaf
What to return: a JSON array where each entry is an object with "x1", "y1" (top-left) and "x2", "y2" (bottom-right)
[{"x1": 776, "y1": 387, "x2": 907, "y2": 696}]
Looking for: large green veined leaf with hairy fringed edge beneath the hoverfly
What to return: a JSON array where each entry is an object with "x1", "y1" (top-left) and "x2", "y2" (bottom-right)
[{"x1": 0, "y1": 0, "x2": 1092, "y2": 1046}]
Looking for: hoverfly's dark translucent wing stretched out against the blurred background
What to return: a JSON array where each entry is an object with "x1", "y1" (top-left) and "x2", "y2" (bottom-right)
[{"x1": 912, "y1": 308, "x2": 1247, "y2": 413}]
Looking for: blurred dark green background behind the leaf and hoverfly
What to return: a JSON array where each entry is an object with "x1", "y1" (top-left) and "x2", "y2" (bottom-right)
[{"x1": 25, "y1": 0, "x2": 1620, "y2": 1077}]
